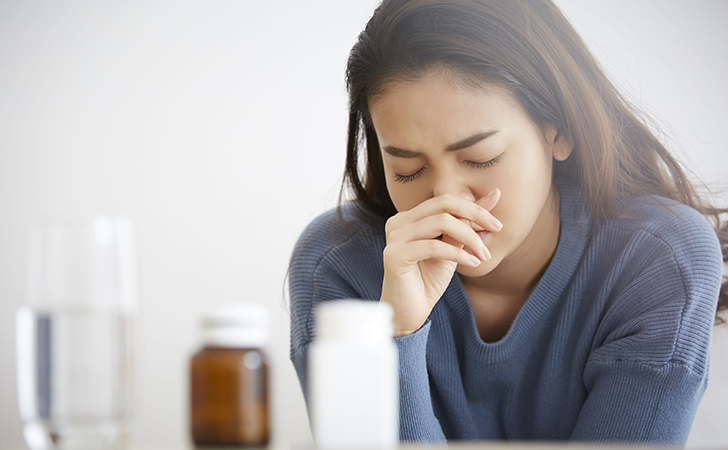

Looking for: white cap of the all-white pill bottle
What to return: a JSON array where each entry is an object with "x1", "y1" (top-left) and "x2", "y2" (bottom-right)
[{"x1": 316, "y1": 300, "x2": 394, "y2": 341}]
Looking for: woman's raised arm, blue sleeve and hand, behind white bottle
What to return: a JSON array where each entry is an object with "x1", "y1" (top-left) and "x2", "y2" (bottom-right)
[{"x1": 290, "y1": 189, "x2": 502, "y2": 442}]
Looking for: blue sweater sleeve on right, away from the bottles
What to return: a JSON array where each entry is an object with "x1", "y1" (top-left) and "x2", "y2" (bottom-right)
[{"x1": 572, "y1": 213, "x2": 722, "y2": 446}]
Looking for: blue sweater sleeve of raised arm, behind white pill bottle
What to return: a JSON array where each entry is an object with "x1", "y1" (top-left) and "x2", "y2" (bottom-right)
[{"x1": 289, "y1": 209, "x2": 445, "y2": 442}]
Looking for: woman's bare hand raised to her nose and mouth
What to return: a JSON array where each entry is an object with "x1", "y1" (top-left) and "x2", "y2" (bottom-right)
[{"x1": 380, "y1": 189, "x2": 503, "y2": 336}]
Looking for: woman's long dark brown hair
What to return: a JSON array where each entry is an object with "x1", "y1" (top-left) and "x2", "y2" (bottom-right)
[{"x1": 342, "y1": 0, "x2": 728, "y2": 322}]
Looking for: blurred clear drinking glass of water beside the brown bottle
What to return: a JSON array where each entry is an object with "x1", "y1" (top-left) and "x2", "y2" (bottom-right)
[{"x1": 16, "y1": 216, "x2": 139, "y2": 450}]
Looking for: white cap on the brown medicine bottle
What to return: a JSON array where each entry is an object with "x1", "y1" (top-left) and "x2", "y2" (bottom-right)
[{"x1": 202, "y1": 303, "x2": 268, "y2": 348}]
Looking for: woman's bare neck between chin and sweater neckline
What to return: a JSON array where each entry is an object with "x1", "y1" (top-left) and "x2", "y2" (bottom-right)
[{"x1": 461, "y1": 186, "x2": 561, "y2": 301}]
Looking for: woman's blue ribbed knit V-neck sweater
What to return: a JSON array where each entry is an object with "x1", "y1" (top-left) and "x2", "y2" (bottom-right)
[{"x1": 289, "y1": 186, "x2": 722, "y2": 445}]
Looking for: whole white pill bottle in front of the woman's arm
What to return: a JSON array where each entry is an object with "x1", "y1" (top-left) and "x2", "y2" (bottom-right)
[{"x1": 308, "y1": 300, "x2": 399, "y2": 449}]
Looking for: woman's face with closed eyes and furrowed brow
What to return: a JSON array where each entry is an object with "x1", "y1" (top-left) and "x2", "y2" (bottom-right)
[{"x1": 369, "y1": 72, "x2": 572, "y2": 277}]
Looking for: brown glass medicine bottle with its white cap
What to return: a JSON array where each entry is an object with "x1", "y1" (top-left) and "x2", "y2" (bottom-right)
[{"x1": 190, "y1": 304, "x2": 270, "y2": 446}]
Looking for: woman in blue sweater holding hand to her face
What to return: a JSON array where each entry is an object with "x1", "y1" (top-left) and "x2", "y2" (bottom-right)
[{"x1": 290, "y1": 0, "x2": 728, "y2": 445}]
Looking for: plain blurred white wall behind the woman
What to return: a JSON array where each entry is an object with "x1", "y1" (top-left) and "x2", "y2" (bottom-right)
[{"x1": 0, "y1": 0, "x2": 728, "y2": 448}]
